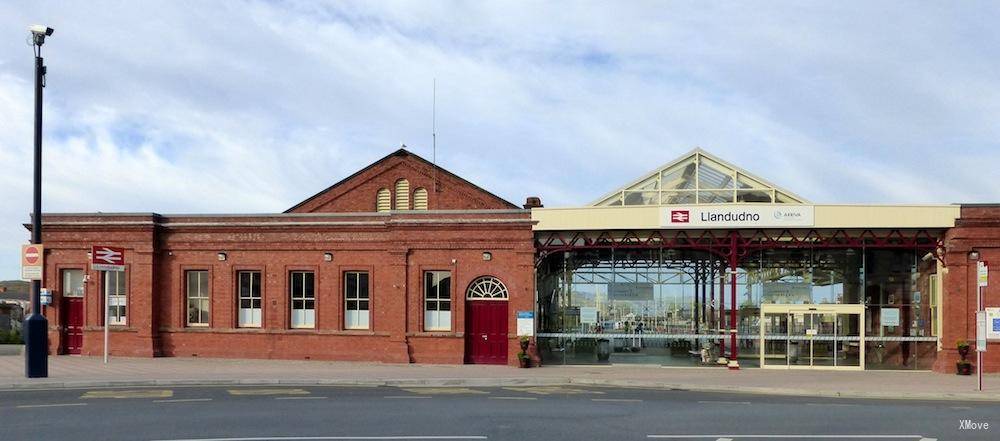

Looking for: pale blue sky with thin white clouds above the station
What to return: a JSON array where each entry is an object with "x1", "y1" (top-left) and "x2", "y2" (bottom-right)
[{"x1": 0, "y1": 0, "x2": 1000, "y2": 279}]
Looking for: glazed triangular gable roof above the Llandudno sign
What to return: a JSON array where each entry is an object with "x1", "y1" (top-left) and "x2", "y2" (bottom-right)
[{"x1": 590, "y1": 148, "x2": 810, "y2": 207}]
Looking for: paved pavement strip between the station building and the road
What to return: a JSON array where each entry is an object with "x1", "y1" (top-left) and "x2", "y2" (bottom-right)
[{"x1": 0, "y1": 356, "x2": 1000, "y2": 401}]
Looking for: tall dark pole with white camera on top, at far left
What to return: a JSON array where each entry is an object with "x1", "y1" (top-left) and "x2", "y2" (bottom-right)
[{"x1": 23, "y1": 25, "x2": 53, "y2": 378}]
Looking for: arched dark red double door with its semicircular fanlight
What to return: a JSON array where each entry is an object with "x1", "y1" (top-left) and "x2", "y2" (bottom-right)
[{"x1": 465, "y1": 276, "x2": 508, "y2": 364}]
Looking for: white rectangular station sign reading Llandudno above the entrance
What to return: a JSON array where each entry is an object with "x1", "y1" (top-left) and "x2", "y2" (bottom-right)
[{"x1": 660, "y1": 205, "x2": 815, "y2": 228}]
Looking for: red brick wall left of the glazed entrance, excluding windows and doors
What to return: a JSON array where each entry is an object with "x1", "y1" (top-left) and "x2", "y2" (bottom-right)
[{"x1": 37, "y1": 210, "x2": 534, "y2": 364}]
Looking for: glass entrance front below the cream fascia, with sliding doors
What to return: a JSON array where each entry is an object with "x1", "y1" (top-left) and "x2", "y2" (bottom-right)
[{"x1": 536, "y1": 237, "x2": 937, "y2": 369}]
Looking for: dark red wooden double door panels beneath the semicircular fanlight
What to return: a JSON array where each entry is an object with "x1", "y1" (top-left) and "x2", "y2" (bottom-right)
[{"x1": 465, "y1": 300, "x2": 507, "y2": 364}]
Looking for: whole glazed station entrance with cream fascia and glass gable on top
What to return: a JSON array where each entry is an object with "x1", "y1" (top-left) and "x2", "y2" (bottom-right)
[{"x1": 532, "y1": 149, "x2": 958, "y2": 369}]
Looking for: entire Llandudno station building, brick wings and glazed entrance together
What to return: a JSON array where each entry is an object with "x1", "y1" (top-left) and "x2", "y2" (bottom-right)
[{"x1": 29, "y1": 149, "x2": 1000, "y2": 372}]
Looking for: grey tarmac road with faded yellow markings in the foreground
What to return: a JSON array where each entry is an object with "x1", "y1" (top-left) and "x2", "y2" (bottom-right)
[{"x1": 0, "y1": 386, "x2": 1000, "y2": 441}]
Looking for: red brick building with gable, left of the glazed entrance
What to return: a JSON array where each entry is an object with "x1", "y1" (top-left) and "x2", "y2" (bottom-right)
[{"x1": 43, "y1": 150, "x2": 534, "y2": 363}]
